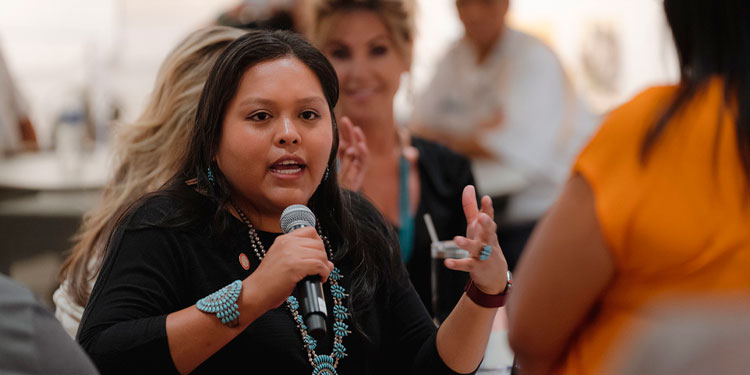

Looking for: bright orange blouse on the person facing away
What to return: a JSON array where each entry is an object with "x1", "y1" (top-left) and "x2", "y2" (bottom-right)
[{"x1": 558, "y1": 79, "x2": 750, "y2": 375}]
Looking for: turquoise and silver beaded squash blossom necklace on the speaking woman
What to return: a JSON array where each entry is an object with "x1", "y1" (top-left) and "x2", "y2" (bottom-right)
[{"x1": 232, "y1": 203, "x2": 351, "y2": 375}]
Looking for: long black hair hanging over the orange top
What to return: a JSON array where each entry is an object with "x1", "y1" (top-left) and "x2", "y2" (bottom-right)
[{"x1": 641, "y1": 0, "x2": 750, "y2": 183}]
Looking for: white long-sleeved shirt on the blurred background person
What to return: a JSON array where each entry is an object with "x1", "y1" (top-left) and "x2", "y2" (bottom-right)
[{"x1": 414, "y1": 28, "x2": 598, "y2": 224}]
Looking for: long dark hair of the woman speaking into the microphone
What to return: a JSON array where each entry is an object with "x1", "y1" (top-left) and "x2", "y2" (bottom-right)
[{"x1": 159, "y1": 31, "x2": 402, "y2": 328}]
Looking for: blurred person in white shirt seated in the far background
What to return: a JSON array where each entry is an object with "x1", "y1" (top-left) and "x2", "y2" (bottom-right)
[{"x1": 410, "y1": 0, "x2": 597, "y2": 270}]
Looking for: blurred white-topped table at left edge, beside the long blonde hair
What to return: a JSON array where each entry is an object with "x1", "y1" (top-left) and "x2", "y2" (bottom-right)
[{"x1": 0, "y1": 148, "x2": 111, "y2": 274}]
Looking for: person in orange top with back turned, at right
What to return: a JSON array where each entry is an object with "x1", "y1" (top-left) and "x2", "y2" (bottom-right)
[{"x1": 508, "y1": 0, "x2": 750, "y2": 375}]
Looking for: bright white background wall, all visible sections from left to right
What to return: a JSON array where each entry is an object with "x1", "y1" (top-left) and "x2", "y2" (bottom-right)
[{"x1": 0, "y1": 0, "x2": 677, "y2": 145}]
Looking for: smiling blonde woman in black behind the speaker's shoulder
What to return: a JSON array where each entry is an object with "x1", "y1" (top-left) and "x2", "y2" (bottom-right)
[{"x1": 311, "y1": 0, "x2": 474, "y2": 321}]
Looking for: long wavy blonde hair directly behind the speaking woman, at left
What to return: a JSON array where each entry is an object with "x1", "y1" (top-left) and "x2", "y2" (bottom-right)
[{"x1": 59, "y1": 26, "x2": 245, "y2": 306}]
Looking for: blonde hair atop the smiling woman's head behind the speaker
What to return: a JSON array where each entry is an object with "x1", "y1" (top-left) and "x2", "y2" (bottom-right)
[{"x1": 308, "y1": 0, "x2": 416, "y2": 66}]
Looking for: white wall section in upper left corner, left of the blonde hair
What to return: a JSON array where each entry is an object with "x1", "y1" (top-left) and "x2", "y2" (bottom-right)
[{"x1": 0, "y1": 0, "x2": 234, "y2": 146}]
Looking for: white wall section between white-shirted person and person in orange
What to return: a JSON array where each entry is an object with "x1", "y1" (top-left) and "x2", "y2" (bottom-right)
[{"x1": 510, "y1": 0, "x2": 679, "y2": 112}]
